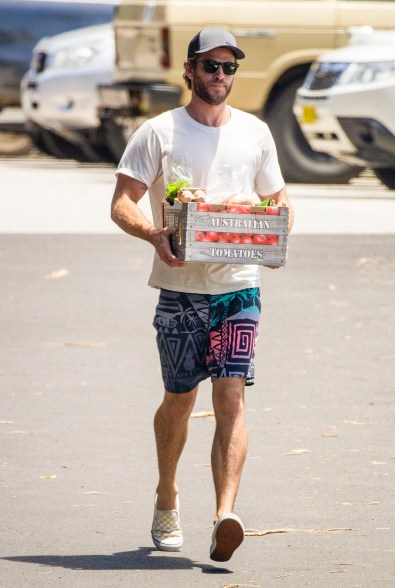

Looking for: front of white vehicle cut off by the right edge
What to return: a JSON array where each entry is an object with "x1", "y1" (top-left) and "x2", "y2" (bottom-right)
[{"x1": 294, "y1": 30, "x2": 395, "y2": 190}]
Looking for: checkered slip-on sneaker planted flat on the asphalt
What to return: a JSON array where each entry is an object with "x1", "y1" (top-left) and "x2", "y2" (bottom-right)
[{"x1": 151, "y1": 495, "x2": 184, "y2": 551}]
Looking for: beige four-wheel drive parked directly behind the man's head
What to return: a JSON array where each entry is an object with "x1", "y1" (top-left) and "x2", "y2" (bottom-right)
[{"x1": 101, "y1": 0, "x2": 395, "y2": 183}]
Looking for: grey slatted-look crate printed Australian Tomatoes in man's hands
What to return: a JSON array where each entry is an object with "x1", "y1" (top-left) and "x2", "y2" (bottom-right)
[{"x1": 163, "y1": 200, "x2": 289, "y2": 267}]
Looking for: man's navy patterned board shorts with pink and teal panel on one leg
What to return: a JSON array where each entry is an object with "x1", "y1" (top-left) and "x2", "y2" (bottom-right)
[{"x1": 153, "y1": 288, "x2": 261, "y2": 394}]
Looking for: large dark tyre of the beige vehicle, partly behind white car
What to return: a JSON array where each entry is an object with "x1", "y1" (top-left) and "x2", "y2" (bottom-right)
[{"x1": 264, "y1": 77, "x2": 361, "y2": 184}]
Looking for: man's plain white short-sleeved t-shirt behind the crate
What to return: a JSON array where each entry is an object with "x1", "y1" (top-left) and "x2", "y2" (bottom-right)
[{"x1": 117, "y1": 107, "x2": 284, "y2": 294}]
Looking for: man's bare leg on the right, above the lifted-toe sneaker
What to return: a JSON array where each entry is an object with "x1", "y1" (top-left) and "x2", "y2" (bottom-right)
[{"x1": 211, "y1": 378, "x2": 247, "y2": 522}]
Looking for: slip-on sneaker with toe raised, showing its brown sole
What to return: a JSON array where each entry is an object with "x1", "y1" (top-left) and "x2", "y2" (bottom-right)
[{"x1": 210, "y1": 513, "x2": 244, "y2": 561}]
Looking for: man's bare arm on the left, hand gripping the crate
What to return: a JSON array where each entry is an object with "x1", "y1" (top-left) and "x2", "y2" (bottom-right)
[{"x1": 111, "y1": 174, "x2": 184, "y2": 267}]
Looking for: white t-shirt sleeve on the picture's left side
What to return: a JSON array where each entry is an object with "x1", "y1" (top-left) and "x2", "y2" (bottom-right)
[{"x1": 116, "y1": 122, "x2": 162, "y2": 188}]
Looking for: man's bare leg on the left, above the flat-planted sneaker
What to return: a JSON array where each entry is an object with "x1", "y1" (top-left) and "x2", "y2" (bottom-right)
[{"x1": 154, "y1": 388, "x2": 197, "y2": 510}]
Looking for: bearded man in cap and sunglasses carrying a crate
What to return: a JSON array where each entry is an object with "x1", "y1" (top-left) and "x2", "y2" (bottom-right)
[{"x1": 112, "y1": 28, "x2": 293, "y2": 561}]
